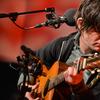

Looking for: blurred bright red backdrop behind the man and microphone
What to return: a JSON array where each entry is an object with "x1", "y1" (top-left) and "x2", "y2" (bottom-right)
[{"x1": 0, "y1": 0, "x2": 80, "y2": 61}]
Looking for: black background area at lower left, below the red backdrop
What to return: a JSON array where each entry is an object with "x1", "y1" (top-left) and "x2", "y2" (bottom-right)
[{"x1": 0, "y1": 61, "x2": 19, "y2": 100}]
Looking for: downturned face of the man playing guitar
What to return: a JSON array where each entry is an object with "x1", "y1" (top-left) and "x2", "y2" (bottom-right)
[{"x1": 82, "y1": 29, "x2": 100, "y2": 52}]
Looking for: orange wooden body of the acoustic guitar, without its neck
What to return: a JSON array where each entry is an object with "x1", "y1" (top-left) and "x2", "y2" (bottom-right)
[{"x1": 37, "y1": 61, "x2": 69, "y2": 100}]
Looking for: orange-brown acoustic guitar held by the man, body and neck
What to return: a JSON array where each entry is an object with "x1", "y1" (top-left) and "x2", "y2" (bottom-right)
[{"x1": 33, "y1": 56, "x2": 100, "y2": 100}]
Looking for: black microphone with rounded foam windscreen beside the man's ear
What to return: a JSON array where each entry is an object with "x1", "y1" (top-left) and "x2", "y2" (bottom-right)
[{"x1": 34, "y1": 8, "x2": 76, "y2": 28}]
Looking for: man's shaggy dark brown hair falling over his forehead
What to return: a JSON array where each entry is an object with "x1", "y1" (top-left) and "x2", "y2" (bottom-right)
[{"x1": 75, "y1": 0, "x2": 100, "y2": 32}]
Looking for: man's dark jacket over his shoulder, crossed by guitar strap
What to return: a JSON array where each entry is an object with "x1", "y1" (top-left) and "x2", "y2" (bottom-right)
[{"x1": 36, "y1": 32, "x2": 77, "y2": 68}]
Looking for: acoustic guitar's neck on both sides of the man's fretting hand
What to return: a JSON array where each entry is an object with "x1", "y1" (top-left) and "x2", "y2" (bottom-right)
[{"x1": 48, "y1": 56, "x2": 100, "y2": 90}]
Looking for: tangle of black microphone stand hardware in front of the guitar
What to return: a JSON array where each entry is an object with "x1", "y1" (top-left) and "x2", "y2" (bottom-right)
[{"x1": 17, "y1": 53, "x2": 42, "y2": 100}]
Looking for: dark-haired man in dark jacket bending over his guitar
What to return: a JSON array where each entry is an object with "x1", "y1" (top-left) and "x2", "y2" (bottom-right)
[{"x1": 18, "y1": 0, "x2": 100, "y2": 100}]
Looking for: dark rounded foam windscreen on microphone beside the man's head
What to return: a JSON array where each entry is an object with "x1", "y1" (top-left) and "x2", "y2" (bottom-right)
[{"x1": 63, "y1": 8, "x2": 77, "y2": 26}]
